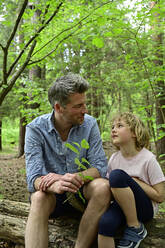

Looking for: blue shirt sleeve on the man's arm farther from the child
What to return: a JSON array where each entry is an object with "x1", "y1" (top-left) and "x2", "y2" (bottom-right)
[{"x1": 25, "y1": 126, "x2": 44, "y2": 192}]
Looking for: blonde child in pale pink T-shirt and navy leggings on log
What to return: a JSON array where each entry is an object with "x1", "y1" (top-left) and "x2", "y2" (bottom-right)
[{"x1": 98, "y1": 113, "x2": 165, "y2": 248}]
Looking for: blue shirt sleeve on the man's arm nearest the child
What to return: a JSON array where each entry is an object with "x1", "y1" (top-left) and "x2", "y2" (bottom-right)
[{"x1": 87, "y1": 121, "x2": 107, "y2": 177}]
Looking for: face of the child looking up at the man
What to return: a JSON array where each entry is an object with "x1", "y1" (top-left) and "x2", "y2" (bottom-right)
[{"x1": 111, "y1": 120, "x2": 136, "y2": 147}]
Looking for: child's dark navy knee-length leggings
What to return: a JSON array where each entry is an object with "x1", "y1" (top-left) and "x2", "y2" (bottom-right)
[{"x1": 98, "y1": 169, "x2": 153, "y2": 237}]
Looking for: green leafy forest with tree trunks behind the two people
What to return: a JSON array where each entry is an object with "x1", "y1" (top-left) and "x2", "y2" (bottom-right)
[{"x1": 0, "y1": 0, "x2": 165, "y2": 166}]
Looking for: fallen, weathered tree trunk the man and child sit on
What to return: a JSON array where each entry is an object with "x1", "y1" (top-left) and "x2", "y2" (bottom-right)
[{"x1": 0, "y1": 200, "x2": 165, "y2": 248}]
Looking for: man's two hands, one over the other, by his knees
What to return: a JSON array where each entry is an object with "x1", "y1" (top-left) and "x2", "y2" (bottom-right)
[{"x1": 39, "y1": 173, "x2": 84, "y2": 194}]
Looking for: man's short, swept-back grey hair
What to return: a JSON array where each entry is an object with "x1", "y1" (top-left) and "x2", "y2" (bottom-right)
[{"x1": 48, "y1": 73, "x2": 89, "y2": 108}]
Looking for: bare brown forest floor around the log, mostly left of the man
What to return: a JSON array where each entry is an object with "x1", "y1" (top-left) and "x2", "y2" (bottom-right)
[{"x1": 0, "y1": 154, "x2": 165, "y2": 248}]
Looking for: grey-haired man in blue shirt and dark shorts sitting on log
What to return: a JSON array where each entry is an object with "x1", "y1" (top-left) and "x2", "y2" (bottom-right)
[{"x1": 25, "y1": 73, "x2": 110, "y2": 248}]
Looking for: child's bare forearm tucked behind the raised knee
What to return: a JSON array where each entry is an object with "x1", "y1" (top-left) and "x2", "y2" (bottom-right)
[{"x1": 133, "y1": 177, "x2": 165, "y2": 203}]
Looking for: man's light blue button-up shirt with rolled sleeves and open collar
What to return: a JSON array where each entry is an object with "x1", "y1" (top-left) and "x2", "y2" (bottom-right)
[{"x1": 25, "y1": 112, "x2": 107, "y2": 192}]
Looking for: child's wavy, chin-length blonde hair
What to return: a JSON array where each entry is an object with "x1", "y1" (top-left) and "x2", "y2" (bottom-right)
[{"x1": 112, "y1": 112, "x2": 149, "y2": 149}]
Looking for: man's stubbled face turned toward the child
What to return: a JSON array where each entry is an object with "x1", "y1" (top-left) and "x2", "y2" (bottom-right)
[{"x1": 62, "y1": 93, "x2": 88, "y2": 125}]
